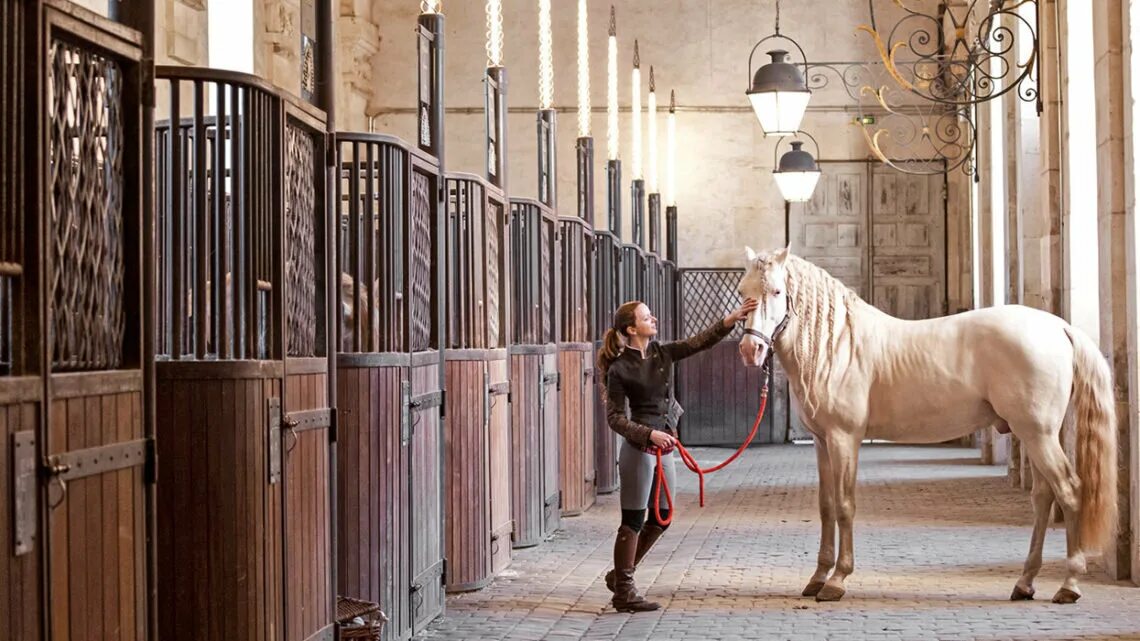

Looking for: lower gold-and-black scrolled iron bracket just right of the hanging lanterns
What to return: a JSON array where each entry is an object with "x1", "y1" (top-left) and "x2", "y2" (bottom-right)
[{"x1": 807, "y1": 60, "x2": 977, "y2": 176}]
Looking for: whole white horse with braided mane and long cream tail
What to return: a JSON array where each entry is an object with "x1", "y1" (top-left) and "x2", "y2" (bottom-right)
[{"x1": 738, "y1": 248, "x2": 1117, "y2": 603}]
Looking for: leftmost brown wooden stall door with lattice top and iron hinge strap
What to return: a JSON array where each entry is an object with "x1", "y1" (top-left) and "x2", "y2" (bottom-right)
[{"x1": 42, "y1": 3, "x2": 153, "y2": 641}]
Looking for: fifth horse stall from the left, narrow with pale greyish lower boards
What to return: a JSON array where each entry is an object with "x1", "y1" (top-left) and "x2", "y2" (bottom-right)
[{"x1": 508, "y1": 198, "x2": 561, "y2": 540}]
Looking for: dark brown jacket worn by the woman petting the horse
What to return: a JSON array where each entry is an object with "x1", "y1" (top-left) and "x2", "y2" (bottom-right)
[{"x1": 605, "y1": 321, "x2": 732, "y2": 447}]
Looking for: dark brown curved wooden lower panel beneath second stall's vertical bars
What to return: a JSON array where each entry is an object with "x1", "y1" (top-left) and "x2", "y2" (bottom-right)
[{"x1": 156, "y1": 365, "x2": 284, "y2": 641}]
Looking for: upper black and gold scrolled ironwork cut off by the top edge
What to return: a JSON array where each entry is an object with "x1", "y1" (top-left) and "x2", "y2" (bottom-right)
[{"x1": 858, "y1": 0, "x2": 1042, "y2": 113}]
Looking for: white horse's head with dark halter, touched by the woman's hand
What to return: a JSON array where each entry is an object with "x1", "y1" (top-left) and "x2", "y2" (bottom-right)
[{"x1": 736, "y1": 242, "x2": 788, "y2": 367}]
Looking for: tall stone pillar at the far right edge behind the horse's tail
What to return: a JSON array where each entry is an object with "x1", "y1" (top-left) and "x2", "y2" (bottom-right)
[{"x1": 1092, "y1": 0, "x2": 1137, "y2": 579}]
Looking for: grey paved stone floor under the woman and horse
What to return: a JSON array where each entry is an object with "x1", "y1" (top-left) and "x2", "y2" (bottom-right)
[{"x1": 420, "y1": 445, "x2": 1140, "y2": 641}]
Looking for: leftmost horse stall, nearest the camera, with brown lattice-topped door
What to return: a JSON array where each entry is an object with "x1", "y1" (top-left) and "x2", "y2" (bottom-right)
[{"x1": 0, "y1": 0, "x2": 154, "y2": 641}]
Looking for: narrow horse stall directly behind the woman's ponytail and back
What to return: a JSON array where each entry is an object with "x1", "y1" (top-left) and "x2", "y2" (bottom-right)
[{"x1": 589, "y1": 229, "x2": 622, "y2": 494}]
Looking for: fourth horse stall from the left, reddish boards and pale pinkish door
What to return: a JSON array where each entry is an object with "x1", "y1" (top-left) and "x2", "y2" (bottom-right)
[{"x1": 443, "y1": 173, "x2": 513, "y2": 592}]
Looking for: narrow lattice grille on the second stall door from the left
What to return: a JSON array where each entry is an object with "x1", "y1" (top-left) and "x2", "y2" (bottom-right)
[{"x1": 285, "y1": 123, "x2": 318, "y2": 356}]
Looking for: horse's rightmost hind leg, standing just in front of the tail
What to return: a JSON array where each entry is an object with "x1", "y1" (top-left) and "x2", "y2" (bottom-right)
[{"x1": 1021, "y1": 435, "x2": 1085, "y2": 603}]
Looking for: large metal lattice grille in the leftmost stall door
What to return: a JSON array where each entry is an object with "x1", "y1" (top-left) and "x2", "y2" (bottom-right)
[{"x1": 48, "y1": 40, "x2": 125, "y2": 371}]
